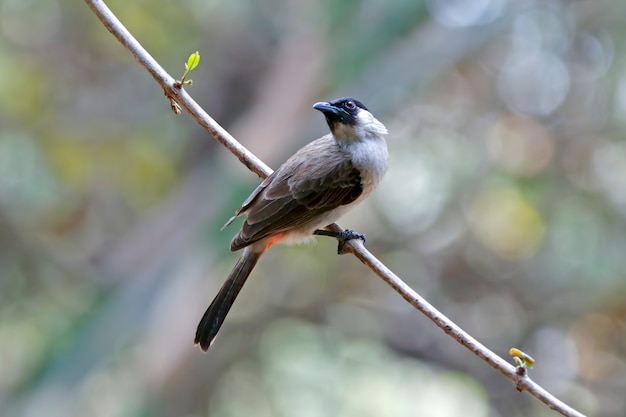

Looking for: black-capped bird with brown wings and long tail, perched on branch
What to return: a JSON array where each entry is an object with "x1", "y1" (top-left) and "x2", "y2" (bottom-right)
[{"x1": 195, "y1": 97, "x2": 388, "y2": 351}]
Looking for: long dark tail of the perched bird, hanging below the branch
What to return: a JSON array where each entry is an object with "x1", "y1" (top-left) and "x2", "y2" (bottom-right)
[{"x1": 195, "y1": 249, "x2": 262, "y2": 351}]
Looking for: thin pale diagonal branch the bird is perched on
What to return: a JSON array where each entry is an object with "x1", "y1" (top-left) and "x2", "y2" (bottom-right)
[{"x1": 85, "y1": 0, "x2": 584, "y2": 417}]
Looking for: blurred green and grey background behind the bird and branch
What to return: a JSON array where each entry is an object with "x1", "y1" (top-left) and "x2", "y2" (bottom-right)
[{"x1": 0, "y1": 0, "x2": 626, "y2": 417}]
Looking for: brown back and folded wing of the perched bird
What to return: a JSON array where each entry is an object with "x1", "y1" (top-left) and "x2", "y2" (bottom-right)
[{"x1": 231, "y1": 137, "x2": 363, "y2": 251}]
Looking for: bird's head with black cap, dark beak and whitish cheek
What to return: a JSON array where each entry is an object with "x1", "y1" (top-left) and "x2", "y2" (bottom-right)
[{"x1": 313, "y1": 97, "x2": 387, "y2": 140}]
